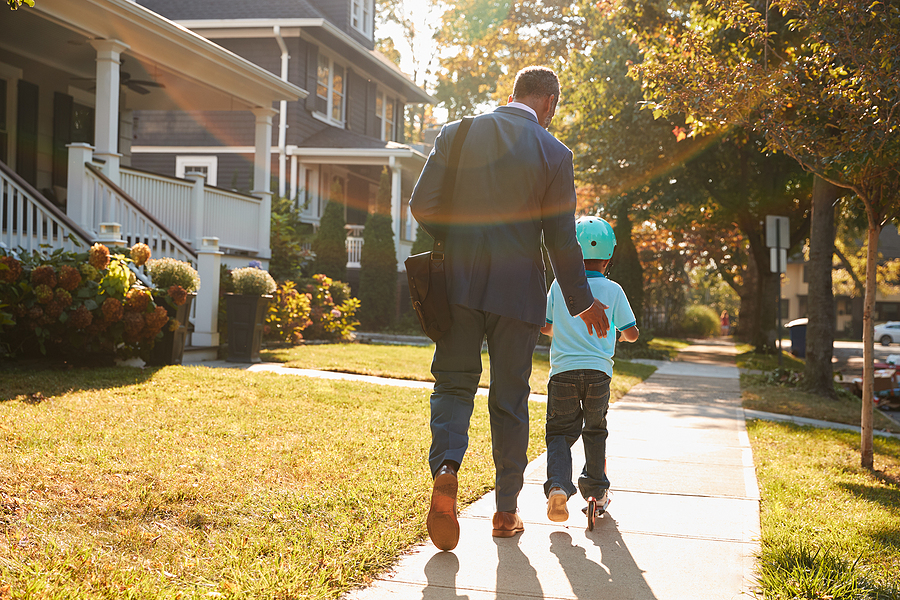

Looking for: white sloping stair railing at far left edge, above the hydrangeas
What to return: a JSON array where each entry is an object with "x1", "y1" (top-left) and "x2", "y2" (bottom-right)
[{"x1": 0, "y1": 162, "x2": 93, "y2": 254}]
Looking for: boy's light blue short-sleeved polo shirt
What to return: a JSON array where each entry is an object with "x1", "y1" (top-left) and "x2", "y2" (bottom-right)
[{"x1": 547, "y1": 271, "x2": 636, "y2": 377}]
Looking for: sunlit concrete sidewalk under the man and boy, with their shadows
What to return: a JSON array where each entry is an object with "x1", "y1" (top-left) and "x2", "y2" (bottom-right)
[{"x1": 348, "y1": 344, "x2": 759, "y2": 600}]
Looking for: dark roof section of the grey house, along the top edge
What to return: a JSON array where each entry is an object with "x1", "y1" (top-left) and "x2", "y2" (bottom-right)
[{"x1": 138, "y1": 0, "x2": 325, "y2": 21}]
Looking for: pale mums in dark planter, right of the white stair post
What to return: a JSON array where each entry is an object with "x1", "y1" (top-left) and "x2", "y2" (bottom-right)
[{"x1": 225, "y1": 266, "x2": 276, "y2": 363}]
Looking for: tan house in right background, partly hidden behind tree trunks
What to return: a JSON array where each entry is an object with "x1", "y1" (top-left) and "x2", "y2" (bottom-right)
[{"x1": 781, "y1": 225, "x2": 900, "y2": 339}]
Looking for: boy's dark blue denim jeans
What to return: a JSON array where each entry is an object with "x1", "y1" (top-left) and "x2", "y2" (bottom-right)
[{"x1": 544, "y1": 369, "x2": 610, "y2": 498}]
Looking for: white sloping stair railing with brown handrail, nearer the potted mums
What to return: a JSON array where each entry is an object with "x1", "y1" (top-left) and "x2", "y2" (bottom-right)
[{"x1": 85, "y1": 165, "x2": 197, "y2": 264}]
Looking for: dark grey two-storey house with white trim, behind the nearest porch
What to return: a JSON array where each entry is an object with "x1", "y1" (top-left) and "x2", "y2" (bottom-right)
[{"x1": 132, "y1": 0, "x2": 433, "y2": 284}]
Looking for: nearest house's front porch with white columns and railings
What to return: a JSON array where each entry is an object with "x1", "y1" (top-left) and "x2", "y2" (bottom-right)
[{"x1": 0, "y1": 0, "x2": 308, "y2": 346}]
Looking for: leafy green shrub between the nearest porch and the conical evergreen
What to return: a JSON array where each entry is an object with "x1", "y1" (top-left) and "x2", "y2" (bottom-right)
[{"x1": 269, "y1": 197, "x2": 313, "y2": 281}]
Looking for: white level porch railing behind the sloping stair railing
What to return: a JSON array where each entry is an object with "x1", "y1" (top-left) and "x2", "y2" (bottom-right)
[{"x1": 119, "y1": 167, "x2": 260, "y2": 254}]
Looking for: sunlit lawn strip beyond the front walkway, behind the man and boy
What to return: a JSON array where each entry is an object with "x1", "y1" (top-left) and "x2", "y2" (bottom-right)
[{"x1": 262, "y1": 344, "x2": 655, "y2": 400}]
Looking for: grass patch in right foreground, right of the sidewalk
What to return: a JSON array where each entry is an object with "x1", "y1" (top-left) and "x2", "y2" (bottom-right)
[{"x1": 747, "y1": 421, "x2": 900, "y2": 600}]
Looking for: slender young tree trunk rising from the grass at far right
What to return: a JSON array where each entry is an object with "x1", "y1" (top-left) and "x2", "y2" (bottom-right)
[{"x1": 859, "y1": 220, "x2": 881, "y2": 469}]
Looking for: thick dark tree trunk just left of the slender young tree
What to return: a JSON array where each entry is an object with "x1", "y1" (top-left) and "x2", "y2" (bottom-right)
[{"x1": 803, "y1": 177, "x2": 841, "y2": 398}]
